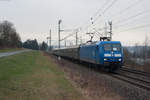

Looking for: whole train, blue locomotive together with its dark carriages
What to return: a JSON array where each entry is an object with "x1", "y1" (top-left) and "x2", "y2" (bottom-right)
[{"x1": 52, "y1": 41, "x2": 123, "y2": 72}]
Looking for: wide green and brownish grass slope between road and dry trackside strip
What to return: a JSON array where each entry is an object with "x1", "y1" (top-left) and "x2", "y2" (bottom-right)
[{"x1": 0, "y1": 51, "x2": 83, "y2": 100}]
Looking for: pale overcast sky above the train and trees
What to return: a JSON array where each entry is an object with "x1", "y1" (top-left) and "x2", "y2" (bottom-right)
[{"x1": 0, "y1": 0, "x2": 150, "y2": 45}]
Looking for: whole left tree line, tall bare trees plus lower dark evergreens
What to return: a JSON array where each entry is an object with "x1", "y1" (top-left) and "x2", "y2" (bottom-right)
[{"x1": 0, "y1": 21, "x2": 48, "y2": 51}]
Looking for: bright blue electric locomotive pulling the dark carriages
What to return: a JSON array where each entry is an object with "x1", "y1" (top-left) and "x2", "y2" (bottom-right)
[{"x1": 79, "y1": 41, "x2": 123, "y2": 71}]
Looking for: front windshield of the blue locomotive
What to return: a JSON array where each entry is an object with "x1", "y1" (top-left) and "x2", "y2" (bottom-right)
[{"x1": 104, "y1": 44, "x2": 121, "y2": 51}]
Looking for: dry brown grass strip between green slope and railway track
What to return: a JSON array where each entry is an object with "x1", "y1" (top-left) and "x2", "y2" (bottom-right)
[{"x1": 47, "y1": 56, "x2": 122, "y2": 100}]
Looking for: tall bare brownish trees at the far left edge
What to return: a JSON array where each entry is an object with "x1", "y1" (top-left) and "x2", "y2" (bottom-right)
[{"x1": 0, "y1": 21, "x2": 22, "y2": 48}]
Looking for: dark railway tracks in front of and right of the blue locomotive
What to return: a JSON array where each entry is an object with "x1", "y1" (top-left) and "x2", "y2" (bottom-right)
[{"x1": 111, "y1": 68, "x2": 150, "y2": 91}]
